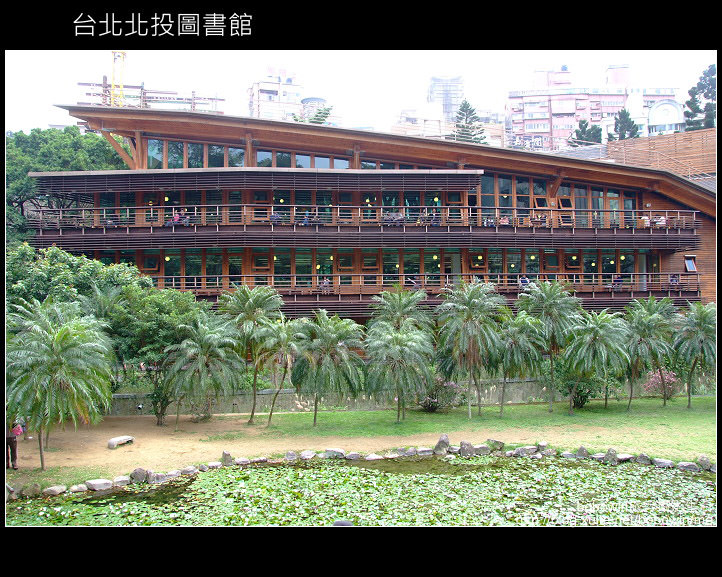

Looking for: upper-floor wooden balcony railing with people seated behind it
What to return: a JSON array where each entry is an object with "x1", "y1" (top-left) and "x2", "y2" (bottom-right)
[{"x1": 27, "y1": 204, "x2": 700, "y2": 231}]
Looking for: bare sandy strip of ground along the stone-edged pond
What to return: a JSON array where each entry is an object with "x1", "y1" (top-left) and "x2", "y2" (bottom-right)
[{"x1": 9, "y1": 415, "x2": 640, "y2": 476}]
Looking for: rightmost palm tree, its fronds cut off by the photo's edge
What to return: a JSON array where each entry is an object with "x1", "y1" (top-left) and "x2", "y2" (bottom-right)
[{"x1": 674, "y1": 303, "x2": 717, "y2": 409}]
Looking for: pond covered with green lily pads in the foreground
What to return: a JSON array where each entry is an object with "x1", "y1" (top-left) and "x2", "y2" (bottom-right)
[{"x1": 6, "y1": 456, "x2": 717, "y2": 526}]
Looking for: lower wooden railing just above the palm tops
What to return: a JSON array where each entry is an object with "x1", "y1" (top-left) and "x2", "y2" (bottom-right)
[{"x1": 152, "y1": 272, "x2": 700, "y2": 295}]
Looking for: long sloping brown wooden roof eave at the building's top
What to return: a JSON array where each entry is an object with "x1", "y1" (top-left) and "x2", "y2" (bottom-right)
[{"x1": 61, "y1": 106, "x2": 716, "y2": 216}]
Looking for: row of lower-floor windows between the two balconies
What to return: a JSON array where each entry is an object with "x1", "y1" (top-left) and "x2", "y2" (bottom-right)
[{"x1": 100, "y1": 247, "x2": 660, "y2": 276}]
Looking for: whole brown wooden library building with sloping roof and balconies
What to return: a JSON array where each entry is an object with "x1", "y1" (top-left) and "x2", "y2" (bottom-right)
[{"x1": 29, "y1": 106, "x2": 716, "y2": 319}]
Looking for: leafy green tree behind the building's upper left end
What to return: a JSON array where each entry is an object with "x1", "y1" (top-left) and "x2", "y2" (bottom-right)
[{"x1": 5, "y1": 126, "x2": 127, "y2": 242}]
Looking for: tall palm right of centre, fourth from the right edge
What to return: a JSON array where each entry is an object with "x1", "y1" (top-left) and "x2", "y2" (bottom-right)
[{"x1": 516, "y1": 281, "x2": 581, "y2": 413}]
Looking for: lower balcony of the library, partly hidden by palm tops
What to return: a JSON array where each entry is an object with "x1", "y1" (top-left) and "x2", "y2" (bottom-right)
[{"x1": 152, "y1": 272, "x2": 700, "y2": 316}]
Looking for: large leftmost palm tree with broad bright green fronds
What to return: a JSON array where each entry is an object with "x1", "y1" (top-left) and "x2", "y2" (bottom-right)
[{"x1": 6, "y1": 298, "x2": 113, "y2": 470}]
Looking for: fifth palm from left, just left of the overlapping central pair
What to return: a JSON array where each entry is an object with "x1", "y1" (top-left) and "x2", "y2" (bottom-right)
[{"x1": 291, "y1": 309, "x2": 364, "y2": 427}]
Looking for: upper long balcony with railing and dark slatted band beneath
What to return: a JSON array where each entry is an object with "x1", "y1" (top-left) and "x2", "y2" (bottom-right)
[{"x1": 28, "y1": 204, "x2": 701, "y2": 250}]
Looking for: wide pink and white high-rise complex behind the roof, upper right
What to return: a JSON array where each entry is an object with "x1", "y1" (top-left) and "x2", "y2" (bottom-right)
[{"x1": 507, "y1": 65, "x2": 684, "y2": 150}]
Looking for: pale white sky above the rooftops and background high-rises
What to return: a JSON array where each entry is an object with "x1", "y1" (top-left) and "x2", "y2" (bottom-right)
[{"x1": 5, "y1": 47, "x2": 717, "y2": 133}]
